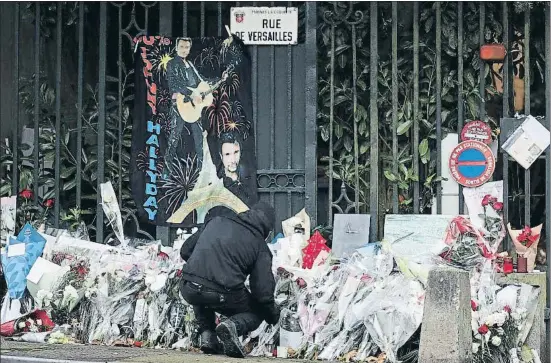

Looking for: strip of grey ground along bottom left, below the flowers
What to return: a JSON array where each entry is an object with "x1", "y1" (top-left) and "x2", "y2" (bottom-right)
[{"x1": 0, "y1": 339, "x2": 304, "y2": 363}]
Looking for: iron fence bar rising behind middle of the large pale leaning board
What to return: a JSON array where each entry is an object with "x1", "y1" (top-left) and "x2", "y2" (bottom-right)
[{"x1": 413, "y1": 1, "x2": 420, "y2": 214}]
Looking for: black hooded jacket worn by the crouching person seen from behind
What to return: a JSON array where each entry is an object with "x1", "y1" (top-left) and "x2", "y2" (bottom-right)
[{"x1": 180, "y1": 203, "x2": 275, "y2": 304}]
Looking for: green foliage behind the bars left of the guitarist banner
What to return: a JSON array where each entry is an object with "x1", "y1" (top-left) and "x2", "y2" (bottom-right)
[{"x1": 0, "y1": 65, "x2": 134, "y2": 239}]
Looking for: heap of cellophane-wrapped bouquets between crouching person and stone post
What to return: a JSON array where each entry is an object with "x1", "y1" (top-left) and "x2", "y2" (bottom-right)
[{"x1": 248, "y1": 225, "x2": 424, "y2": 361}]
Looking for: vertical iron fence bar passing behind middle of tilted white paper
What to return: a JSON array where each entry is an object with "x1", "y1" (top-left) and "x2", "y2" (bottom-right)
[{"x1": 523, "y1": 7, "x2": 532, "y2": 226}]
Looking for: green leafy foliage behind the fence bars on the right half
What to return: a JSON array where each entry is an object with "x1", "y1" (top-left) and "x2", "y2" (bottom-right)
[{"x1": 318, "y1": 2, "x2": 543, "y2": 213}]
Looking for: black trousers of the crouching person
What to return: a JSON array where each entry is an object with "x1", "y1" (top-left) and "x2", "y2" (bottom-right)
[{"x1": 180, "y1": 280, "x2": 263, "y2": 336}]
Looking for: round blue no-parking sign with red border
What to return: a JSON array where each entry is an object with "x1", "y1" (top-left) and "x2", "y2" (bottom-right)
[{"x1": 449, "y1": 140, "x2": 496, "y2": 188}]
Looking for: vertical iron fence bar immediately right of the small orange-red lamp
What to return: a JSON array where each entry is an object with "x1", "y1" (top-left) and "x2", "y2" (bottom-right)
[{"x1": 502, "y1": 1, "x2": 512, "y2": 251}]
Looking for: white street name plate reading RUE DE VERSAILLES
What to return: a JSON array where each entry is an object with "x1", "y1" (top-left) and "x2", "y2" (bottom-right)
[{"x1": 230, "y1": 7, "x2": 298, "y2": 45}]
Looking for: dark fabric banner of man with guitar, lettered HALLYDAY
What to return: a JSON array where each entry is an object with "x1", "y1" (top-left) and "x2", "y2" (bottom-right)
[{"x1": 130, "y1": 36, "x2": 257, "y2": 226}]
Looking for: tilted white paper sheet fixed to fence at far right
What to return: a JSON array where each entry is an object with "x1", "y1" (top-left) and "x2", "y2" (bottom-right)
[{"x1": 502, "y1": 116, "x2": 550, "y2": 169}]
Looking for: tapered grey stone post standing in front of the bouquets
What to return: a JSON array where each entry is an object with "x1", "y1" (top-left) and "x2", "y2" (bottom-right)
[{"x1": 419, "y1": 267, "x2": 472, "y2": 363}]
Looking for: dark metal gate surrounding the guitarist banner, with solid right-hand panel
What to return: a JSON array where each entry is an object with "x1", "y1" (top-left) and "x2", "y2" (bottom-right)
[{"x1": 2, "y1": 1, "x2": 317, "y2": 245}]
